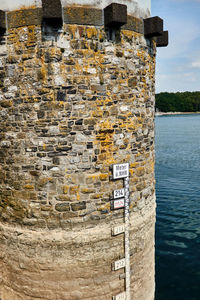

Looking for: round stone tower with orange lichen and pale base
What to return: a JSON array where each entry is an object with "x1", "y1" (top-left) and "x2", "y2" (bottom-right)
[{"x1": 0, "y1": 0, "x2": 167, "y2": 300}]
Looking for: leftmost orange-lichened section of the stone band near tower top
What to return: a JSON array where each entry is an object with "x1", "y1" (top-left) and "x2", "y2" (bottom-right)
[{"x1": 7, "y1": 8, "x2": 42, "y2": 29}]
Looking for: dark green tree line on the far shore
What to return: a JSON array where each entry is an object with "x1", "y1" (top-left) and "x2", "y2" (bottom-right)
[{"x1": 156, "y1": 92, "x2": 200, "y2": 112}]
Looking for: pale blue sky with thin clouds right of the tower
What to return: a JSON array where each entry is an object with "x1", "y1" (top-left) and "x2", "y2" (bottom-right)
[{"x1": 151, "y1": 0, "x2": 200, "y2": 93}]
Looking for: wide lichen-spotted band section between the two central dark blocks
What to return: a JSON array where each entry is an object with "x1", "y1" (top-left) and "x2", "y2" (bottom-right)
[{"x1": 63, "y1": 7, "x2": 103, "y2": 26}]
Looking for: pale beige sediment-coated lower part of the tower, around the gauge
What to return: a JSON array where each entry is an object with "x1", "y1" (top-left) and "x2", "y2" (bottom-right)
[{"x1": 0, "y1": 202, "x2": 155, "y2": 300}]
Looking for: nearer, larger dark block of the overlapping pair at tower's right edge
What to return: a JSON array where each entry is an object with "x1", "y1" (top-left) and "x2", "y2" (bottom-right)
[{"x1": 144, "y1": 17, "x2": 163, "y2": 38}]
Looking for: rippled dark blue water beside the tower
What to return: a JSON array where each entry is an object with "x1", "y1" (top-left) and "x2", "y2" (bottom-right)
[{"x1": 156, "y1": 115, "x2": 200, "y2": 300}]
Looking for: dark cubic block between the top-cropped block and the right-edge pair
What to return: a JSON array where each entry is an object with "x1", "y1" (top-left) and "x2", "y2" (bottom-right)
[{"x1": 104, "y1": 3, "x2": 127, "y2": 27}]
